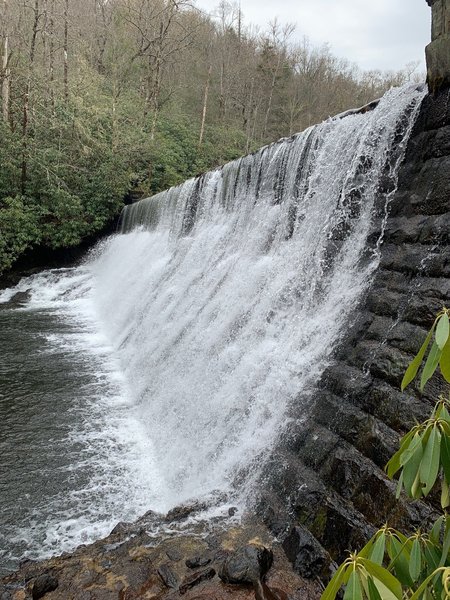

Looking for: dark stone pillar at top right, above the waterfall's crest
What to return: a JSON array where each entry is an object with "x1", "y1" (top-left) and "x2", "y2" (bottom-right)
[{"x1": 425, "y1": 0, "x2": 450, "y2": 93}]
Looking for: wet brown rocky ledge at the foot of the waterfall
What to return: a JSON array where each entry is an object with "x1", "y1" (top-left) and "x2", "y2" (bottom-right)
[{"x1": 0, "y1": 504, "x2": 322, "y2": 600}]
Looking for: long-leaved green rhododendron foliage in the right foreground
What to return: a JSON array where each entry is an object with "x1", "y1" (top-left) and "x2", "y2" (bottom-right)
[{"x1": 322, "y1": 308, "x2": 450, "y2": 600}]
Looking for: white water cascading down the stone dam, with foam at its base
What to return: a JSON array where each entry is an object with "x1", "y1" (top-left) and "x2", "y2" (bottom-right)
[{"x1": 0, "y1": 86, "x2": 424, "y2": 572}]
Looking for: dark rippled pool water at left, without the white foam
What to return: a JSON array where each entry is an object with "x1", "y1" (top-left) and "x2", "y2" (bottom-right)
[{"x1": 0, "y1": 309, "x2": 92, "y2": 568}]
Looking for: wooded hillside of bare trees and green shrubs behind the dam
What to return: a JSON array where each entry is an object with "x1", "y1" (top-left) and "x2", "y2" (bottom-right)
[{"x1": 0, "y1": 0, "x2": 417, "y2": 273}]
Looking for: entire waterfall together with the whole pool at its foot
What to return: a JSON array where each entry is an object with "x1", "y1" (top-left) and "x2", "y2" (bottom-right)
[{"x1": 0, "y1": 86, "x2": 424, "y2": 570}]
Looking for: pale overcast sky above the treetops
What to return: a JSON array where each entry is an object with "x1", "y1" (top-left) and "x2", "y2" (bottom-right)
[{"x1": 195, "y1": 0, "x2": 431, "y2": 71}]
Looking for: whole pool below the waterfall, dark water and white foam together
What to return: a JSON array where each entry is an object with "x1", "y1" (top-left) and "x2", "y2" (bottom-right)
[{"x1": 0, "y1": 270, "x2": 160, "y2": 576}]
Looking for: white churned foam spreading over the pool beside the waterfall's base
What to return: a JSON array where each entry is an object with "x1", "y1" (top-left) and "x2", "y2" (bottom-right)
[{"x1": 0, "y1": 267, "x2": 165, "y2": 567}]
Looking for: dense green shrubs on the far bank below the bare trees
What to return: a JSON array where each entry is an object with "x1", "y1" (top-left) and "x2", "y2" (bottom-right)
[{"x1": 0, "y1": 74, "x2": 253, "y2": 273}]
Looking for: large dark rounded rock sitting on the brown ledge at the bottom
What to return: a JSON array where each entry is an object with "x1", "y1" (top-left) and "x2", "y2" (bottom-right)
[{"x1": 219, "y1": 545, "x2": 273, "y2": 584}]
